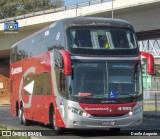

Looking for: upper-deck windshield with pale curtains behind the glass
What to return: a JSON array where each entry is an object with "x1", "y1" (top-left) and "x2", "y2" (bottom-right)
[{"x1": 68, "y1": 27, "x2": 137, "y2": 49}]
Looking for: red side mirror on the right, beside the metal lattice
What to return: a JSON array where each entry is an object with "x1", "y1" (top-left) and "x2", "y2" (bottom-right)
[{"x1": 141, "y1": 52, "x2": 155, "y2": 75}]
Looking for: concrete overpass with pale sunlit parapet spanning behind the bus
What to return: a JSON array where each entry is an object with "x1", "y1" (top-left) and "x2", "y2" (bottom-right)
[{"x1": 0, "y1": 0, "x2": 160, "y2": 58}]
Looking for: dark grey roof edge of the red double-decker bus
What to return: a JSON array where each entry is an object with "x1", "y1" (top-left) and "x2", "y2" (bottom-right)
[{"x1": 11, "y1": 17, "x2": 133, "y2": 48}]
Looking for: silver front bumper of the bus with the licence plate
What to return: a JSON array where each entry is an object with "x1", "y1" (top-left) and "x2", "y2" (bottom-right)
[{"x1": 66, "y1": 112, "x2": 143, "y2": 129}]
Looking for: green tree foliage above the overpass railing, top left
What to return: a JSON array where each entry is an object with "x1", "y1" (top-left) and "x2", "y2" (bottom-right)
[{"x1": 0, "y1": 0, "x2": 64, "y2": 19}]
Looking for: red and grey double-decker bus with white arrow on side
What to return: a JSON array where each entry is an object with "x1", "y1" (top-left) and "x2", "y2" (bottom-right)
[{"x1": 10, "y1": 17, "x2": 154, "y2": 133}]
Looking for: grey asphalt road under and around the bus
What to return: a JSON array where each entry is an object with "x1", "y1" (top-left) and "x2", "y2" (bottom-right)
[{"x1": 0, "y1": 106, "x2": 160, "y2": 139}]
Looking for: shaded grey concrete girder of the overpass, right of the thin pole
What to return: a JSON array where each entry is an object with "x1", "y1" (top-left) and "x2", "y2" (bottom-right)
[{"x1": 115, "y1": 7, "x2": 160, "y2": 32}]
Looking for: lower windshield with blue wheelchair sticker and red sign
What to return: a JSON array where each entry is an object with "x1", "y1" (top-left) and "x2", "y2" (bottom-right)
[{"x1": 68, "y1": 62, "x2": 142, "y2": 98}]
